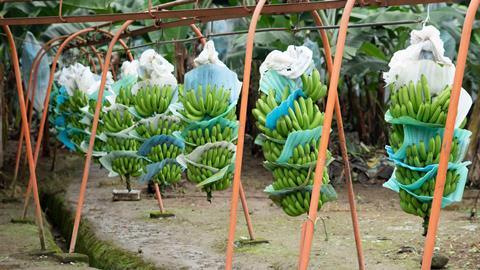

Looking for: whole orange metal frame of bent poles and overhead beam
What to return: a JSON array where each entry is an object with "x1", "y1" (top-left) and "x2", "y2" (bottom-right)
[{"x1": 0, "y1": 0, "x2": 480, "y2": 270}]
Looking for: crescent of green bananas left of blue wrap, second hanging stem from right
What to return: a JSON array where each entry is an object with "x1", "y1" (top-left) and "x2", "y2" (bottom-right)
[{"x1": 252, "y1": 88, "x2": 289, "y2": 139}]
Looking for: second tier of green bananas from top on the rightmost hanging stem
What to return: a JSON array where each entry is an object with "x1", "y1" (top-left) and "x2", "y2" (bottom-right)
[{"x1": 405, "y1": 134, "x2": 460, "y2": 167}]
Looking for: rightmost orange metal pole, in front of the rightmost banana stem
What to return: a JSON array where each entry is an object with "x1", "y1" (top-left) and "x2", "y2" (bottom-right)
[{"x1": 422, "y1": 0, "x2": 479, "y2": 270}]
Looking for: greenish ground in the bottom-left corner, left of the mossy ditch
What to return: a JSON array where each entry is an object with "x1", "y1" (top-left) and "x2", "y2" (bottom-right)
[{"x1": 0, "y1": 191, "x2": 94, "y2": 270}]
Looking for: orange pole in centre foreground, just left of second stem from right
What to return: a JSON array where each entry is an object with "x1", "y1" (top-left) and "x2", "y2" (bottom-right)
[{"x1": 225, "y1": 0, "x2": 266, "y2": 270}]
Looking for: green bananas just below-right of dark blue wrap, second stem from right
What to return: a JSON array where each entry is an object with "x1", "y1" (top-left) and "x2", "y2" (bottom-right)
[{"x1": 277, "y1": 97, "x2": 324, "y2": 138}]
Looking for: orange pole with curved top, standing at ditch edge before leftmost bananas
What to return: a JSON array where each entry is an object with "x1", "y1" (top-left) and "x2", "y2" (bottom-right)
[{"x1": 69, "y1": 20, "x2": 134, "y2": 253}]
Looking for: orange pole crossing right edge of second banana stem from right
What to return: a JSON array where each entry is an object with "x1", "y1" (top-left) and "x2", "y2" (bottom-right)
[{"x1": 299, "y1": 0, "x2": 355, "y2": 270}]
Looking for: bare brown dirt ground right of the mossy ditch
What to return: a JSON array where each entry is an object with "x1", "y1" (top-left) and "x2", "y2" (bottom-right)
[{"x1": 60, "y1": 152, "x2": 480, "y2": 270}]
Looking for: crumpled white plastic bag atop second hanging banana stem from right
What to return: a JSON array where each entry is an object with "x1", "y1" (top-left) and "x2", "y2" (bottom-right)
[{"x1": 260, "y1": 45, "x2": 313, "y2": 79}]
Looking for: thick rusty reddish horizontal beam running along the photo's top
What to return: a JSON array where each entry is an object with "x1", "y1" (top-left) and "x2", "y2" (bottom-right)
[{"x1": 0, "y1": 0, "x2": 451, "y2": 25}]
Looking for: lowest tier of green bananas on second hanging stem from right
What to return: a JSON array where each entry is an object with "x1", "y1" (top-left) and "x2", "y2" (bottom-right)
[{"x1": 281, "y1": 191, "x2": 326, "y2": 217}]
